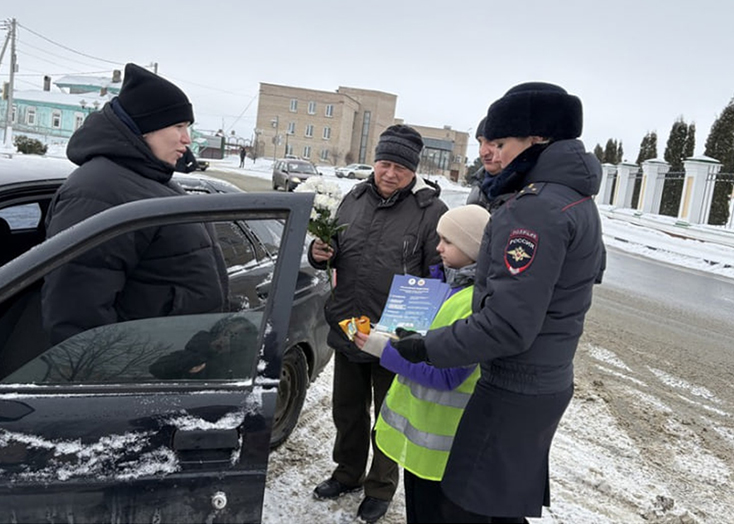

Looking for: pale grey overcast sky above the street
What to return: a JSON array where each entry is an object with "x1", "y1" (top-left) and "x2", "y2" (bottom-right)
[{"x1": 0, "y1": 0, "x2": 734, "y2": 161}]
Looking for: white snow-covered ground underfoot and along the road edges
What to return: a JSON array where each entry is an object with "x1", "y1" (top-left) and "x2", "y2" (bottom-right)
[{"x1": 0, "y1": 149, "x2": 734, "y2": 524}]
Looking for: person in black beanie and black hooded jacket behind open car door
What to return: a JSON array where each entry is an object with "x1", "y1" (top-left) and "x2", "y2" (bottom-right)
[{"x1": 41, "y1": 64, "x2": 228, "y2": 344}]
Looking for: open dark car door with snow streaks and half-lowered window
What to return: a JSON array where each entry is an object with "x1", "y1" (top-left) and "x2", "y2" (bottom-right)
[{"x1": 0, "y1": 193, "x2": 313, "y2": 523}]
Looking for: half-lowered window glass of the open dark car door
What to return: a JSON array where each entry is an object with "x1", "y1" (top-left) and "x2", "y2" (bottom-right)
[{"x1": 2, "y1": 310, "x2": 262, "y2": 384}]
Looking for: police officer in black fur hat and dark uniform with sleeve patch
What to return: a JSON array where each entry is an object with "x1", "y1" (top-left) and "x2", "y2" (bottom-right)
[{"x1": 392, "y1": 82, "x2": 604, "y2": 523}]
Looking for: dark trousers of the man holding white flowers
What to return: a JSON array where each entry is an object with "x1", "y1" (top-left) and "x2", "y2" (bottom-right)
[{"x1": 331, "y1": 351, "x2": 400, "y2": 500}]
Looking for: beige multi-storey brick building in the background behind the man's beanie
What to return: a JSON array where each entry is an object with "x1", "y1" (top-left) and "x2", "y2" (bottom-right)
[{"x1": 251, "y1": 83, "x2": 469, "y2": 180}]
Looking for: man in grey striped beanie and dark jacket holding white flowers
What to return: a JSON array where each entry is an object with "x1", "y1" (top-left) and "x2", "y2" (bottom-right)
[{"x1": 309, "y1": 125, "x2": 447, "y2": 522}]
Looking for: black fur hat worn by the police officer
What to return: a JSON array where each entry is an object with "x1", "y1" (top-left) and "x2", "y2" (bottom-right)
[{"x1": 484, "y1": 82, "x2": 583, "y2": 140}]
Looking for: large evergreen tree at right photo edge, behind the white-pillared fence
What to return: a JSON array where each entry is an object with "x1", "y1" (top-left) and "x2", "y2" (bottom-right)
[{"x1": 703, "y1": 99, "x2": 734, "y2": 225}]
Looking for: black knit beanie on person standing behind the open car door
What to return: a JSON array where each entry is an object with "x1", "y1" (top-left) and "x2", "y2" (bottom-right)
[{"x1": 117, "y1": 64, "x2": 194, "y2": 134}]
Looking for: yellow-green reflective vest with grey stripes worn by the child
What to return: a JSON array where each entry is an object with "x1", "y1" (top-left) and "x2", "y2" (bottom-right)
[{"x1": 375, "y1": 286, "x2": 480, "y2": 481}]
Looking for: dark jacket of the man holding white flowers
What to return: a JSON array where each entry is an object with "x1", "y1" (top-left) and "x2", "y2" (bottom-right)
[{"x1": 309, "y1": 175, "x2": 448, "y2": 362}]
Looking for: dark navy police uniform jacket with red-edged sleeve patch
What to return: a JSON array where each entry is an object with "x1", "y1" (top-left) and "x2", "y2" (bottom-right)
[{"x1": 426, "y1": 140, "x2": 604, "y2": 394}]
